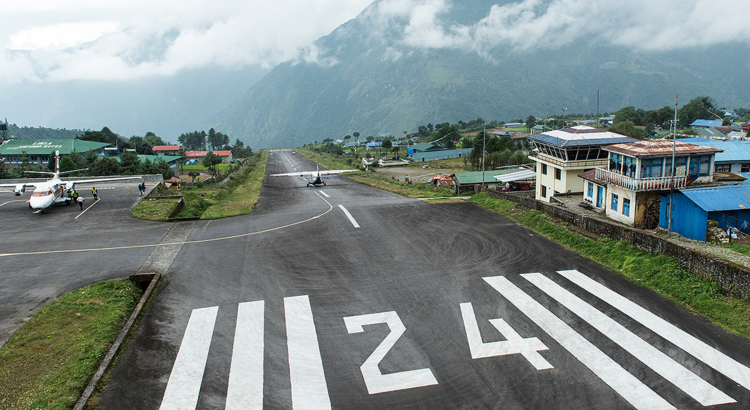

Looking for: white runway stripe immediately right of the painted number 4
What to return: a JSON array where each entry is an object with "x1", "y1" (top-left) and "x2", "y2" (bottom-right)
[{"x1": 483, "y1": 276, "x2": 674, "y2": 410}]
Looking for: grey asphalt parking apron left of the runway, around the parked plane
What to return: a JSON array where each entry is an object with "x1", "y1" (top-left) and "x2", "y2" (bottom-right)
[{"x1": 0, "y1": 183, "x2": 170, "y2": 346}]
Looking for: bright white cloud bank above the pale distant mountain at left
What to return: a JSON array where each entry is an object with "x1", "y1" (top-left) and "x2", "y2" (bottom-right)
[{"x1": 0, "y1": 0, "x2": 370, "y2": 81}]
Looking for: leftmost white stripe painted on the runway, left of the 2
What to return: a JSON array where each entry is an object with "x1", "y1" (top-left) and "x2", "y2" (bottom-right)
[{"x1": 159, "y1": 306, "x2": 219, "y2": 410}]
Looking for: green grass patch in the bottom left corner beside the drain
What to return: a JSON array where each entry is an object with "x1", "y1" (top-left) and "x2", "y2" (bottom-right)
[{"x1": 0, "y1": 279, "x2": 142, "y2": 410}]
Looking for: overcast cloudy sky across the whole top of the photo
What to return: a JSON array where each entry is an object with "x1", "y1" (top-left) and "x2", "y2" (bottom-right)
[{"x1": 0, "y1": 0, "x2": 750, "y2": 82}]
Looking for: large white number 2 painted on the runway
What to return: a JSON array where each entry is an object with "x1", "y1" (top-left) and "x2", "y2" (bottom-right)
[{"x1": 344, "y1": 312, "x2": 438, "y2": 394}]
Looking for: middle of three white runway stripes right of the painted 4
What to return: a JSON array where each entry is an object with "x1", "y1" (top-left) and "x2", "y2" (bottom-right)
[{"x1": 521, "y1": 273, "x2": 736, "y2": 406}]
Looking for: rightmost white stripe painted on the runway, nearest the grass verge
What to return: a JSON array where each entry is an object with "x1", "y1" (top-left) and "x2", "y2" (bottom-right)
[{"x1": 558, "y1": 270, "x2": 750, "y2": 389}]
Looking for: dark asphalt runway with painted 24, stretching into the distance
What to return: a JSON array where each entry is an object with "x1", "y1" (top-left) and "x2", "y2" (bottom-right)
[{"x1": 86, "y1": 151, "x2": 750, "y2": 409}]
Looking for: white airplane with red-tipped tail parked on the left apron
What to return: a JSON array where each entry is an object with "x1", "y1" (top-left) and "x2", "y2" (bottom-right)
[{"x1": 0, "y1": 151, "x2": 141, "y2": 213}]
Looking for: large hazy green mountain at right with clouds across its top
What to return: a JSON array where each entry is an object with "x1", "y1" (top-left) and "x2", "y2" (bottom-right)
[{"x1": 209, "y1": 0, "x2": 750, "y2": 148}]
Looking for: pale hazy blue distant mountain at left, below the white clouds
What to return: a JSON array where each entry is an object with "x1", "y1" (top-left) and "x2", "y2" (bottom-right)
[{"x1": 0, "y1": 66, "x2": 269, "y2": 143}]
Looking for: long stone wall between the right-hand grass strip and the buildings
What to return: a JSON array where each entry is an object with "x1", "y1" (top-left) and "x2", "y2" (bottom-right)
[{"x1": 488, "y1": 189, "x2": 750, "y2": 298}]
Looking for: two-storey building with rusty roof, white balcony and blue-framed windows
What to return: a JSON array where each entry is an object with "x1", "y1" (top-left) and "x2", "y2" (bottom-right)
[{"x1": 582, "y1": 140, "x2": 721, "y2": 229}]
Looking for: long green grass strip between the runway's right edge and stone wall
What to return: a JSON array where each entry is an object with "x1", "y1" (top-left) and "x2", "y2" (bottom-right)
[{"x1": 467, "y1": 193, "x2": 750, "y2": 339}]
